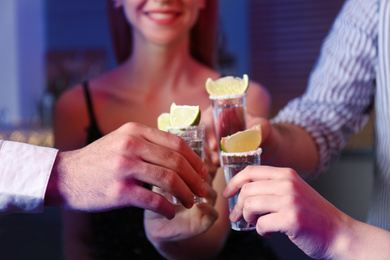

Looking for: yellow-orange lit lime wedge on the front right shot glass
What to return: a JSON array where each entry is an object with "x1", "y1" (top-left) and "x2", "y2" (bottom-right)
[{"x1": 221, "y1": 127, "x2": 262, "y2": 153}]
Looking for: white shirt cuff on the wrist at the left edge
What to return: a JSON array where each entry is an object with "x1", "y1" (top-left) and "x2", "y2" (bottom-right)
[{"x1": 0, "y1": 140, "x2": 58, "y2": 213}]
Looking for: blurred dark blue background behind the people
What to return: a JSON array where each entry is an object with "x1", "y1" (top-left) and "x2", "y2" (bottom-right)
[{"x1": 0, "y1": 0, "x2": 373, "y2": 259}]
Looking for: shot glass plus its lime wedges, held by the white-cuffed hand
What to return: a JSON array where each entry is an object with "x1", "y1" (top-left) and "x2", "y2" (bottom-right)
[{"x1": 157, "y1": 103, "x2": 205, "y2": 205}]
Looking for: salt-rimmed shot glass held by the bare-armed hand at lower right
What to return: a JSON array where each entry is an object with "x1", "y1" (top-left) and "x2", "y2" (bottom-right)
[{"x1": 221, "y1": 148, "x2": 262, "y2": 231}]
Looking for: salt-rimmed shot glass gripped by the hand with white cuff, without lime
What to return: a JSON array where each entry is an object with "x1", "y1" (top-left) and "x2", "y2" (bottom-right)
[{"x1": 167, "y1": 125, "x2": 205, "y2": 205}]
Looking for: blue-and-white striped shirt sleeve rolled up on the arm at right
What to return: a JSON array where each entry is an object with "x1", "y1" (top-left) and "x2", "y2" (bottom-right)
[{"x1": 272, "y1": 0, "x2": 379, "y2": 177}]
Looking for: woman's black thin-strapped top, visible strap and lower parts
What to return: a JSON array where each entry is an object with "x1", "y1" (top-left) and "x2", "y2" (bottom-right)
[{"x1": 83, "y1": 82, "x2": 277, "y2": 260}]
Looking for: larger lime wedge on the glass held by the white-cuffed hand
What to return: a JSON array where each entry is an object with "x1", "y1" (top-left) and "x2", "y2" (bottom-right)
[{"x1": 170, "y1": 103, "x2": 200, "y2": 126}]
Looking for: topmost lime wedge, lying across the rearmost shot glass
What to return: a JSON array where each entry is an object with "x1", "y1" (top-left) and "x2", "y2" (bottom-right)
[{"x1": 206, "y1": 74, "x2": 249, "y2": 96}]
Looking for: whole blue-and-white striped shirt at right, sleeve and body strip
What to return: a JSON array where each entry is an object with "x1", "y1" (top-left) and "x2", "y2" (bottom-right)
[{"x1": 272, "y1": 0, "x2": 390, "y2": 230}]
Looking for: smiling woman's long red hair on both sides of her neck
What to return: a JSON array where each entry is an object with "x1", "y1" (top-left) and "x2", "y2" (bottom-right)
[{"x1": 107, "y1": 0, "x2": 219, "y2": 68}]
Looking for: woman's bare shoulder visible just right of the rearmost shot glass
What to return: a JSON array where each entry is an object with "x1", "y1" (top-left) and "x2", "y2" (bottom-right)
[{"x1": 247, "y1": 81, "x2": 271, "y2": 117}]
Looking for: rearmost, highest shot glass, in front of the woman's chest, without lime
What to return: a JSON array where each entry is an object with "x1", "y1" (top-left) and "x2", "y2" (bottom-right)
[{"x1": 210, "y1": 93, "x2": 246, "y2": 151}]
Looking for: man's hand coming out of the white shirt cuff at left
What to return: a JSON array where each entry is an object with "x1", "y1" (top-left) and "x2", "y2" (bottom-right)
[{"x1": 45, "y1": 123, "x2": 207, "y2": 219}]
